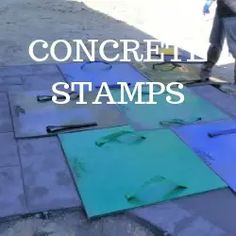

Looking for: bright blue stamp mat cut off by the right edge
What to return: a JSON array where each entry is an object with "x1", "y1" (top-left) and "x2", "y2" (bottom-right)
[{"x1": 174, "y1": 120, "x2": 236, "y2": 193}]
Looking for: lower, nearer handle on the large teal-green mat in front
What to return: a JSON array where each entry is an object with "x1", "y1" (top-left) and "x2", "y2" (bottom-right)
[{"x1": 125, "y1": 175, "x2": 188, "y2": 202}]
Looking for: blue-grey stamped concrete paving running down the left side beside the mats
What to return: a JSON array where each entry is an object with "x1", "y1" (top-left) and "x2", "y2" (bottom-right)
[{"x1": 0, "y1": 65, "x2": 80, "y2": 217}]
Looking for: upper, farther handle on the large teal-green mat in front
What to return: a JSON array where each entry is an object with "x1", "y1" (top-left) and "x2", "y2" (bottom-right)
[{"x1": 95, "y1": 130, "x2": 146, "y2": 147}]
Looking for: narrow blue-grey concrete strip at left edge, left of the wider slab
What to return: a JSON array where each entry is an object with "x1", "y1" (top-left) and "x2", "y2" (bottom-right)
[{"x1": 0, "y1": 132, "x2": 27, "y2": 217}]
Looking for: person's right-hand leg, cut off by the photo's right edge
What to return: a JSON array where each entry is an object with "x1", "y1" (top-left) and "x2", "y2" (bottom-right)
[{"x1": 223, "y1": 17, "x2": 236, "y2": 84}]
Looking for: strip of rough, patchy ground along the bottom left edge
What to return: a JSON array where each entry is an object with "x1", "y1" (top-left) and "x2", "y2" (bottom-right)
[{"x1": 0, "y1": 210, "x2": 161, "y2": 236}]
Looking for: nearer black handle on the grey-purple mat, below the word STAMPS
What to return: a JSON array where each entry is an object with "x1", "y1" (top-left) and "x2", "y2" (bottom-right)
[{"x1": 46, "y1": 122, "x2": 98, "y2": 134}]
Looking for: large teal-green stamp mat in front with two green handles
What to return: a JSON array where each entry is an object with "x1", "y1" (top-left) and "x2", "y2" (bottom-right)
[{"x1": 59, "y1": 126, "x2": 226, "y2": 217}]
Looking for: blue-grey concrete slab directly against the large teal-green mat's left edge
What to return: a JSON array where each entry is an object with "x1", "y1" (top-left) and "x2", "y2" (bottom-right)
[{"x1": 18, "y1": 137, "x2": 80, "y2": 212}]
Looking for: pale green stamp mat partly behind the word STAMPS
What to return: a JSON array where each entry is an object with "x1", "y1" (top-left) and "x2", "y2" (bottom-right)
[{"x1": 112, "y1": 88, "x2": 229, "y2": 130}]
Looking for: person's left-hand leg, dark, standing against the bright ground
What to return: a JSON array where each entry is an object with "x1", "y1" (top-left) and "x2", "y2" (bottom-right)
[{"x1": 200, "y1": 15, "x2": 225, "y2": 80}]
